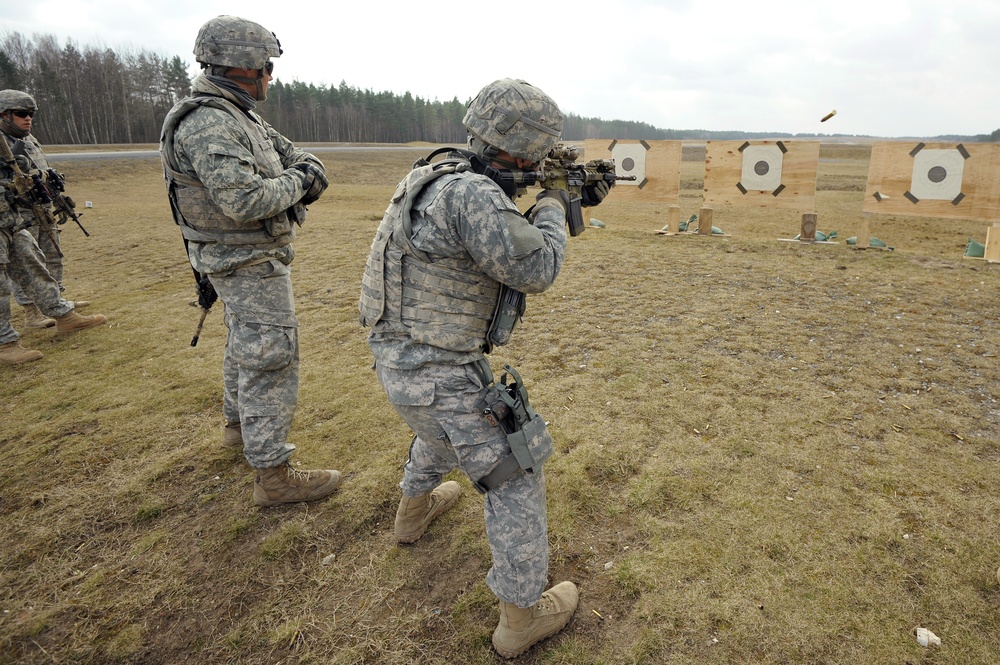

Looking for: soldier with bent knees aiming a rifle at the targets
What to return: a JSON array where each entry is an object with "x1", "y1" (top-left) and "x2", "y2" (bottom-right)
[{"x1": 359, "y1": 79, "x2": 609, "y2": 658}]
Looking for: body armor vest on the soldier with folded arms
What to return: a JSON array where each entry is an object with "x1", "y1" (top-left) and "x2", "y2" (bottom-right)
[{"x1": 160, "y1": 96, "x2": 292, "y2": 247}]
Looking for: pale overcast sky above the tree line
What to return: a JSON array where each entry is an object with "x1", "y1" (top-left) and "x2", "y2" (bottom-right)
[{"x1": 0, "y1": 0, "x2": 1000, "y2": 137}]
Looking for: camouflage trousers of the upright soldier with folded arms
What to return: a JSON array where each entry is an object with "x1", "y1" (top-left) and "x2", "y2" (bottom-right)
[{"x1": 209, "y1": 261, "x2": 299, "y2": 469}]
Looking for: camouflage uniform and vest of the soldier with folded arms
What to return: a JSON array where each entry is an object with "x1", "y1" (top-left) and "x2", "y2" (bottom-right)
[{"x1": 160, "y1": 74, "x2": 323, "y2": 469}]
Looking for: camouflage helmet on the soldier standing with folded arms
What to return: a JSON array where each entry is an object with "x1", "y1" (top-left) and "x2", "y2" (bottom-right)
[{"x1": 194, "y1": 16, "x2": 281, "y2": 69}]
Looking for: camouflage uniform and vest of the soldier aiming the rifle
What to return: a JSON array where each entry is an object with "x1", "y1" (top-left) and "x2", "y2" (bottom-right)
[{"x1": 361, "y1": 153, "x2": 566, "y2": 607}]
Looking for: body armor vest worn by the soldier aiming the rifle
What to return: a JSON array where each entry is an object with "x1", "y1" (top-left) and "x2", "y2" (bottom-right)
[{"x1": 358, "y1": 159, "x2": 523, "y2": 353}]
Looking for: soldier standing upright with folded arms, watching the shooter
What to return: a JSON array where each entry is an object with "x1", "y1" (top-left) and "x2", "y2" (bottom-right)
[{"x1": 160, "y1": 16, "x2": 340, "y2": 506}]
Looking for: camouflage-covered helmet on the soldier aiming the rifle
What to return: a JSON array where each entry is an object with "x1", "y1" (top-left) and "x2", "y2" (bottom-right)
[{"x1": 462, "y1": 79, "x2": 563, "y2": 163}]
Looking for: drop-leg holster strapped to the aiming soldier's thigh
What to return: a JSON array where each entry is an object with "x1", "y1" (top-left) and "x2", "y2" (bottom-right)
[{"x1": 472, "y1": 365, "x2": 554, "y2": 494}]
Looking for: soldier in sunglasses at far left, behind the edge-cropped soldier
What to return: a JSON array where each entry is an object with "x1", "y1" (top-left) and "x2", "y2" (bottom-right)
[{"x1": 0, "y1": 90, "x2": 90, "y2": 328}]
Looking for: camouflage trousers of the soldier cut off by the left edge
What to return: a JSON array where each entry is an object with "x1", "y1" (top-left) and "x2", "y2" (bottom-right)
[{"x1": 0, "y1": 229, "x2": 73, "y2": 344}]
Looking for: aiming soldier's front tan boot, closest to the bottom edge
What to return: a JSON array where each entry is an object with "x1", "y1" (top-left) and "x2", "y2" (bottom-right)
[{"x1": 493, "y1": 582, "x2": 580, "y2": 658}]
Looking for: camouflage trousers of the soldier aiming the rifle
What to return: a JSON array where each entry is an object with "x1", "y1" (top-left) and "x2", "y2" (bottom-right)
[{"x1": 376, "y1": 364, "x2": 549, "y2": 607}]
